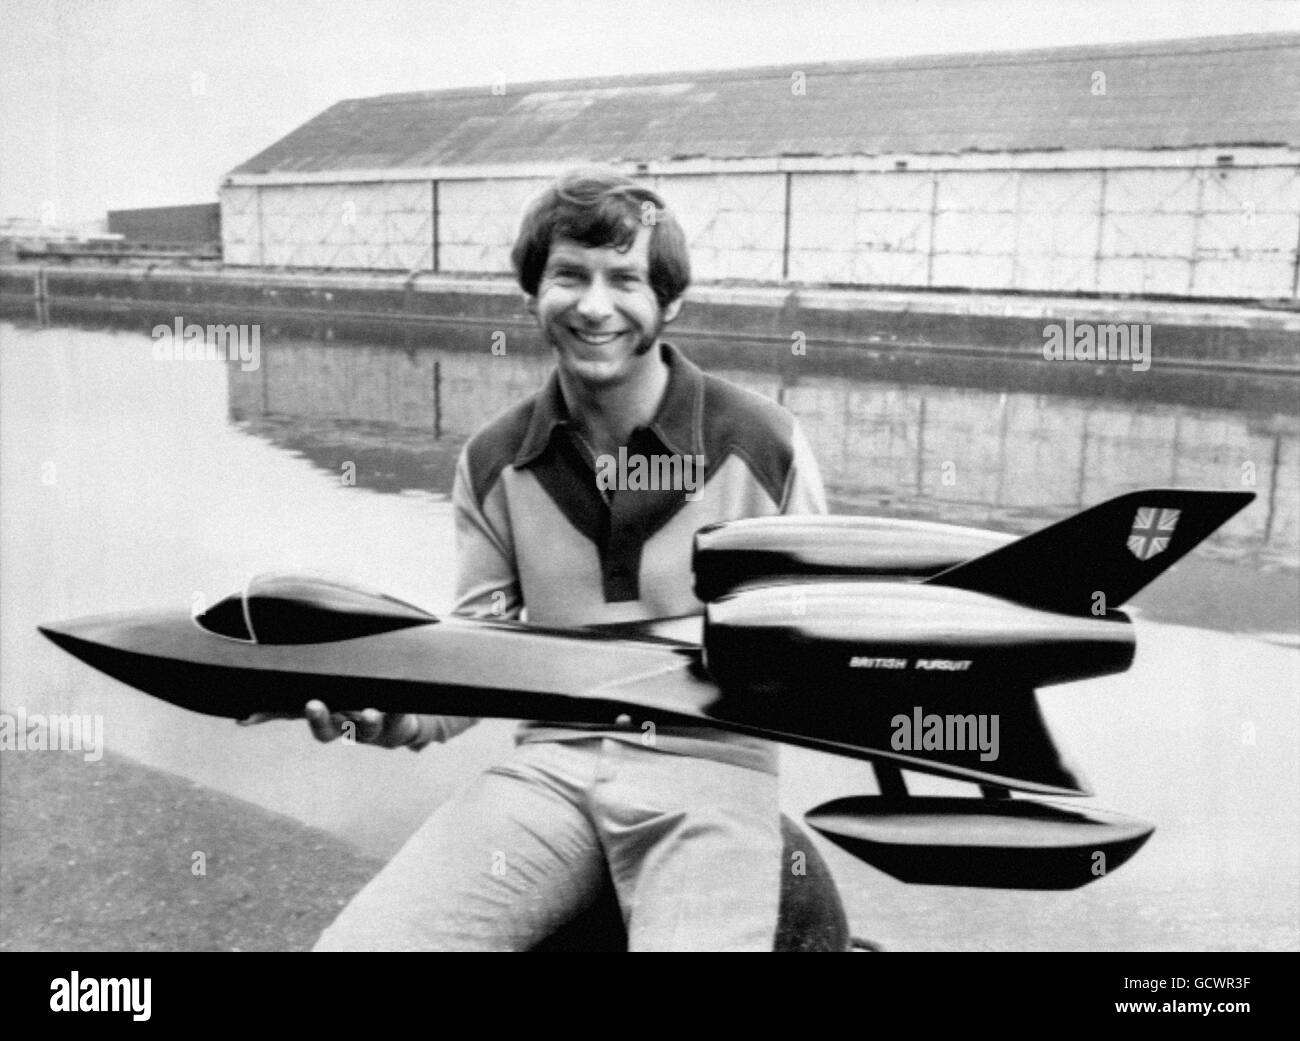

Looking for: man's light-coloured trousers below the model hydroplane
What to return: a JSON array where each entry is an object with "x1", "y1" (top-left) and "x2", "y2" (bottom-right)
[{"x1": 316, "y1": 738, "x2": 783, "y2": 951}]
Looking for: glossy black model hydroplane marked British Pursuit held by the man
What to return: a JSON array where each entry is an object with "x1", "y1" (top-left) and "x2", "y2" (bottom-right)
[{"x1": 40, "y1": 489, "x2": 1255, "y2": 889}]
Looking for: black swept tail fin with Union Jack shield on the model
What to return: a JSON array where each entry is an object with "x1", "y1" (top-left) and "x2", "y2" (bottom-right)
[{"x1": 928, "y1": 489, "x2": 1255, "y2": 615}]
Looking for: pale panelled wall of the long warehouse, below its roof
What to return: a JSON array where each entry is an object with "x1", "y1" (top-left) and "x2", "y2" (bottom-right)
[{"x1": 222, "y1": 160, "x2": 1300, "y2": 299}]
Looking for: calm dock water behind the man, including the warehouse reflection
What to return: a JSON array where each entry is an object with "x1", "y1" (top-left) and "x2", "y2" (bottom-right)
[{"x1": 0, "y1": 314, "x2": 1300, "y2": 946}]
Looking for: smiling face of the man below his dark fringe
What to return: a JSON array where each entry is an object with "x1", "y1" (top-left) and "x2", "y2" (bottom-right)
[{"x1": 529, "y1": 227, "x2": 681, "y2": 389}]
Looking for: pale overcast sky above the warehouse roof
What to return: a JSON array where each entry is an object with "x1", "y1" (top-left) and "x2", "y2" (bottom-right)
[{"x1": 0, "y1": 0, "x2": 1300, "y2": 224}]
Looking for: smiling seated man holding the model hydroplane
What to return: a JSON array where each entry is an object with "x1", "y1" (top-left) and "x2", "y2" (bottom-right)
[{"x1": 308, "y1": 170, "x2": 826, "y2": 950}]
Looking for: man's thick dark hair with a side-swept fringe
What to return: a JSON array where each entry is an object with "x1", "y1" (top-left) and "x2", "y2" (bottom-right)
[{"x1": 510, "y1": 168, "x2": 690, "y2": 308}]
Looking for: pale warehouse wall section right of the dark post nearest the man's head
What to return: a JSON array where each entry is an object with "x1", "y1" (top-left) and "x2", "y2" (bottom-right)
[{"x1": 789, "y1": 168, "x2": 1300, "y2": 298}]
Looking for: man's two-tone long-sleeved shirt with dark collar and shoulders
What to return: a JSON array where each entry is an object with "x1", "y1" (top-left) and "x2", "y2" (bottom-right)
[{"x1": 447, "y1": 343, "x2": 826, "y2": 771}]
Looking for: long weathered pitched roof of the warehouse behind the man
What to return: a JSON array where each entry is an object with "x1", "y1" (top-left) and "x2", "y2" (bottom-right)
[{"x1": 234, "y1": 34, "x2": 1300, "y2": 174}]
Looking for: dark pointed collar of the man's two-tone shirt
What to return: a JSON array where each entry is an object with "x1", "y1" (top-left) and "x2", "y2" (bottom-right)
[{"x1": 515, "y1": 341, "x2": 705, "y2": 467}]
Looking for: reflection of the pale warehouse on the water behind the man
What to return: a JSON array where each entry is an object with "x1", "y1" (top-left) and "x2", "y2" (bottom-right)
[{"x1": 229, "y1": 330, "x2": 1300, "y2": 567}]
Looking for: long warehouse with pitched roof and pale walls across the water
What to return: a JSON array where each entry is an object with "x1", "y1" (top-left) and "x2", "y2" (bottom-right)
[{"x1": 221, "y1": 34, "x2": 1300, "y2": 300}]
